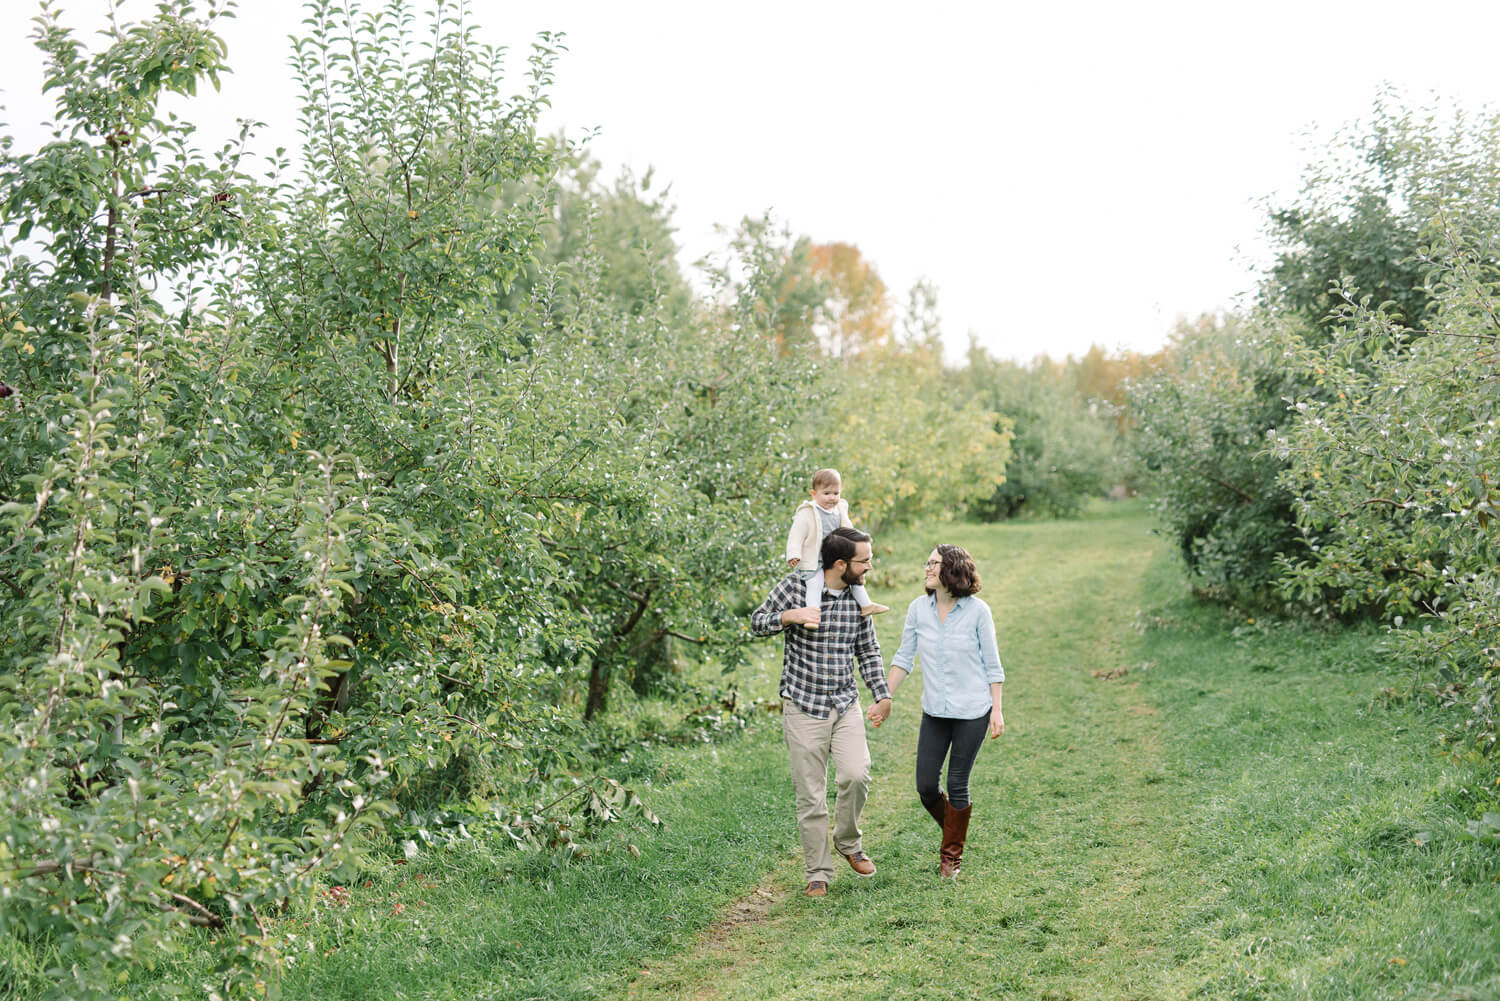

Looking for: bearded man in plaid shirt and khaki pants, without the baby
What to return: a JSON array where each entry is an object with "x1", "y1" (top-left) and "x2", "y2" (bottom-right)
[{"x1": 750, "y1": 528, "x2": 891, "y2": 897}]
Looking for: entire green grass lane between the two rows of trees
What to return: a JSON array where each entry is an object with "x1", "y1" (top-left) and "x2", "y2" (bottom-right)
[{"x1": 111, "y1": 504, "x2": 1500, "y2": 1001}]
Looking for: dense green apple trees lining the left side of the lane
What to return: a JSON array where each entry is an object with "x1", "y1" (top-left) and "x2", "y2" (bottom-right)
[{"x1": 0, "y1": 0, "x2": 1026, "y2": 998}]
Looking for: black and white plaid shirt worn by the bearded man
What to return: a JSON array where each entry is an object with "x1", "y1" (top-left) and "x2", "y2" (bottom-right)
[{"x1": 750, "y1": 573, "x2": 891, "y2": 719}]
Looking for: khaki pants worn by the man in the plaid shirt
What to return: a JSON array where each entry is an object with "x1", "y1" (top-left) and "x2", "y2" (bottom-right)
[{"x1": 782, "y1": 699, "x2": 870, "y2": 882}]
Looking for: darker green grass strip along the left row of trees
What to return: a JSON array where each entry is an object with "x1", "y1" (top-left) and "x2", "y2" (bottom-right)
[{"x1": 178, "y1": 716, "x2": 795, "y2": 1001}]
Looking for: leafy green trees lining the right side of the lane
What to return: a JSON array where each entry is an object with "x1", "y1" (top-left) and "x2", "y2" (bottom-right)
[{"x1": 1131, "y1": 96, "x2": 1500, "y2": 762}]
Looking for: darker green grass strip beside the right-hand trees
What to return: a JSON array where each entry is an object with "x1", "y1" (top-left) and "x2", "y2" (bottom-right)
[{"x1": 1145, "y1": 555, "x2": 1500, "y2": 1001}]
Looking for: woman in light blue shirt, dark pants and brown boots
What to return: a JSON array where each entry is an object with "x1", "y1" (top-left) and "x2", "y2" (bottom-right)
[{"x1": 869, "y1": 545, "x2": 1005, "y2": 876}]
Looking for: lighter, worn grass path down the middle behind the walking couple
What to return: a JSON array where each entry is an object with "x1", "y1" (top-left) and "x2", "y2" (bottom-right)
[{"x1": 630, "y1": 509, "x2": 1217, "y2": 999}]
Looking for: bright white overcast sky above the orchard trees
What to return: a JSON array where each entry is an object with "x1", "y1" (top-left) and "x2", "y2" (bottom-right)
[{"x1": 0, "y1": 0, "x2": 1500, "y2": 359}]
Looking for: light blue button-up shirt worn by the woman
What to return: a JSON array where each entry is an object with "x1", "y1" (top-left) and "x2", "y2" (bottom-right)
[{"x1": 891, "y1": 594, "x2": 1005, "y2": 719}]
